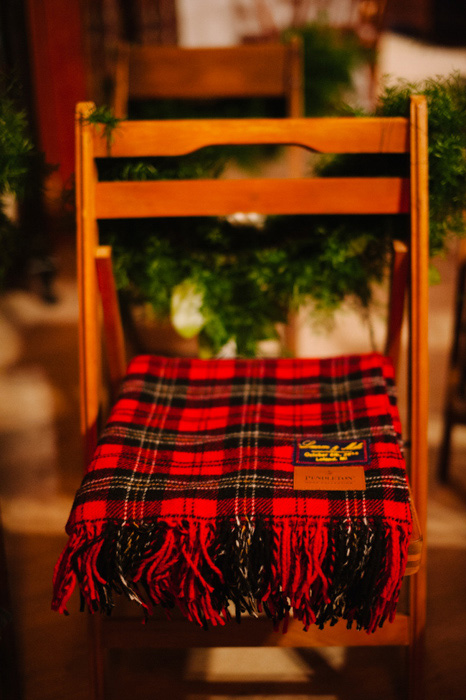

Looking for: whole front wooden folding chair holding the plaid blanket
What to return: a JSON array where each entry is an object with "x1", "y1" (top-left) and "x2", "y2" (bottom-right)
[{"x1": 71, "y1": 97, "x2": 428, "y2": 700}]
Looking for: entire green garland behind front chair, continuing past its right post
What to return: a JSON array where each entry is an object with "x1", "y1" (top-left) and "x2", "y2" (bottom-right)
[{"x1": 90, "y1": 76, "x2": 466, "y2": 356}]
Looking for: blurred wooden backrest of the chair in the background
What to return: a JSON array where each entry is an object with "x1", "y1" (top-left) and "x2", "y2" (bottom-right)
[{"x1": 112, "y1": 37, "x2": 303, "y2": 117}]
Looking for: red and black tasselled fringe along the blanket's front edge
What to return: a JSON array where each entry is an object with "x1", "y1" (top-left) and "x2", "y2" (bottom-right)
[{"x1": 52, "y1": 518, "x2": 411, "y2": 632}]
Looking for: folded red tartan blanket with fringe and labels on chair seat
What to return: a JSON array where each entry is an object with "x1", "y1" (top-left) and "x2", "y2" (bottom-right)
[{"x1": 53, "y1": 353, "x2": 411, "y2": 632}]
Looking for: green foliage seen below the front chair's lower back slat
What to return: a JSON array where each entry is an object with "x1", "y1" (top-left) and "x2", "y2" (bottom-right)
[{"x1": 101, "y1": 216, "x2": 390, "y2": 356}]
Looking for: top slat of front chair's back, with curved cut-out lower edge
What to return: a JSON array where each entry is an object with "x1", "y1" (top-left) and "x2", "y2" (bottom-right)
[{"x1": 94, "y1": 117, "x2": 409, "y2": 158}]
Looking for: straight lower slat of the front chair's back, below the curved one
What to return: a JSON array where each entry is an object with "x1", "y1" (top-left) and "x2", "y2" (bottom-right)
[{"x1": 95, "y1": 178, "x2": 410, "y2": 219}]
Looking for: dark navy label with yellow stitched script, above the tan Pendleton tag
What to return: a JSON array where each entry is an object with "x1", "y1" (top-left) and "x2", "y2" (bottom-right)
[{"x1": 293, "y1": 438, "x2": 369, "y2": 467}]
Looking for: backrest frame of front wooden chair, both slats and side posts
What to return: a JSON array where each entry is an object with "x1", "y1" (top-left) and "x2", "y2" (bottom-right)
[{"x1": 76, "y1": 97, "x2": 429, "y2": 576}]
